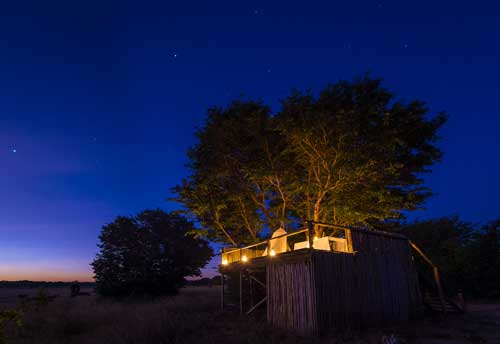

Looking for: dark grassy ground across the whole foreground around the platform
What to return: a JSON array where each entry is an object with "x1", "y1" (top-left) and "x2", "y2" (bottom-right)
[{"x1": 0, "y1": 287, "x2": 500, "y2": 344}]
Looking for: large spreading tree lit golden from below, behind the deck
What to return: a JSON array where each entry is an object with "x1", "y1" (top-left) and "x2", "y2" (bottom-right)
[{"x1": 175, "y1": 78, "x2": 446, "y2": 245}]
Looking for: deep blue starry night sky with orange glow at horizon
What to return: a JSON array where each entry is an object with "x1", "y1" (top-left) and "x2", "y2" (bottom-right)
[{"x1": 0, "y1": 0, "x2": 500, "y2": 281}]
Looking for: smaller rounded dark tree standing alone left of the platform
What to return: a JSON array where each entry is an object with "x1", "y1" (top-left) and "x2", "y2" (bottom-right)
[{"x1": 92, "y1": 210, "x2": 212, "y2": 297}]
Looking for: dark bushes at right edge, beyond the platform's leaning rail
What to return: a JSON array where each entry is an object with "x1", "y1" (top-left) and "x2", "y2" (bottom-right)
[{"x1": 400, "y1": 217, "x2": 500, "y2": 297}]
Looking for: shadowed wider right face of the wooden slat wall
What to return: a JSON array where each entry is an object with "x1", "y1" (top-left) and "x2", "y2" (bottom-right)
[{"x1": 313, "y1": 252, "x2": 421, "y2": 332}]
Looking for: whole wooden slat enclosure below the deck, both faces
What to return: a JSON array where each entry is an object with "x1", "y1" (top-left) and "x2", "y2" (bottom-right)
[{"x1": 267, "y1": 238, "x2": 422, "y2": 334}]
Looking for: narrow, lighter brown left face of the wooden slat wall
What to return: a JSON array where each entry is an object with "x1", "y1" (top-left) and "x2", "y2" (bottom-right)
[{"x1": 267, "y1": 255, "x2": 318, "y2": 334}]
